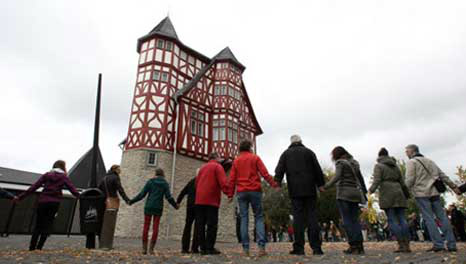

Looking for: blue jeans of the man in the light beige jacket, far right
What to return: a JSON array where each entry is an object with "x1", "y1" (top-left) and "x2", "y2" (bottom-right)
[{"x1": 416, "y1": 196, "x2": 456, "y2": 249}]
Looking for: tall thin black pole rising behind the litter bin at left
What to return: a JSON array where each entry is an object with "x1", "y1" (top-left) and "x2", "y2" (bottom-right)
[{"x1": 86, "y1": 73, "x2": 102, "y2": 249}]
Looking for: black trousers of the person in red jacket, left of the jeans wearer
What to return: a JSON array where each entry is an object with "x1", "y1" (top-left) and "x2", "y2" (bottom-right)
[{"x1": 196, "y1": 205, "x2": 218, "y2": 251}]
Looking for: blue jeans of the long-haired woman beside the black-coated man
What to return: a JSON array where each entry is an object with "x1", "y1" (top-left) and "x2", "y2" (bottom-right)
[{"x1": 337, "y1": 200, "x2": 363, "y2": 243}]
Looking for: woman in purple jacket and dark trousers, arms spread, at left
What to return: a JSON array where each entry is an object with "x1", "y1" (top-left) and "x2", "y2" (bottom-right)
[{"x1": 14, "y1": 160, "x2": 79, "y2": 250}]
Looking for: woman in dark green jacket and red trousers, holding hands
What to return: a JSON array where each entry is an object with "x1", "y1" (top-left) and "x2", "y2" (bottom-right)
[{"x1": 129, "y1": 168, "x2": 179, "y2": 254}]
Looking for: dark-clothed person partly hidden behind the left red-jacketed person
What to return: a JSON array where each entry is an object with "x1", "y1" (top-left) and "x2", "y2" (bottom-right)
[{"x1": 176, "y1": 175, "x2": 199, "y2": 254}]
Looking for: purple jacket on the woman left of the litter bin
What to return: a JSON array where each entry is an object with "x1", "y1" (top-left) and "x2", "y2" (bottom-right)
[{"x1": 18, "y1": 170, "x2": 79, "y2": 203}]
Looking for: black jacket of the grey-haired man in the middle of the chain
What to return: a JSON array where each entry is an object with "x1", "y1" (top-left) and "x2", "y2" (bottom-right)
[{"x1": 275, "y1": 143, "x2": 325, "y2": 198}]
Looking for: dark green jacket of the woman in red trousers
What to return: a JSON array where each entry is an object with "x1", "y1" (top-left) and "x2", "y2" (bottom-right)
[{"x1": 129, "y1": 176, "x2": 176, "y2": 216}]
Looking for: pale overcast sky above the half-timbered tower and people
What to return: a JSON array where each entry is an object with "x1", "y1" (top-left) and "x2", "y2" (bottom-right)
[{"x1": 0, "y1": 0, "x2": 466, "y2": 189}]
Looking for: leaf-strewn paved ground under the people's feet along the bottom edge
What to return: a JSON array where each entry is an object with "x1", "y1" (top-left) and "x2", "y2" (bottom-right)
[{"x1": 0, "y1": 236, "x2": 466, "y2": 264}]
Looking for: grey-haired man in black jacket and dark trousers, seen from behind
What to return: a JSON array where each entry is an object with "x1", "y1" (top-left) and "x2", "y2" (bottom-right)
[{"x1": 275, "y1": 135, "x2": 325, "y2": 255}]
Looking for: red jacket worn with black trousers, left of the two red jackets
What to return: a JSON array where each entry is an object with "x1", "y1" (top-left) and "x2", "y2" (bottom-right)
[{"x1": 195, "y1": 160, "x2": 228, "y2": 207}]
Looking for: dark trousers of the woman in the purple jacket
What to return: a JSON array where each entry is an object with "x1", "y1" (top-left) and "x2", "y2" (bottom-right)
[{"x1": 29, "y1": 202, "x2": 60, "y2": 250}]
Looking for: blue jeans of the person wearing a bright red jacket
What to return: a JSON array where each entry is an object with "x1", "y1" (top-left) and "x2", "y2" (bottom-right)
[{"x1": 237, "y1": 192, "x2": 266, "y2": 250}]
